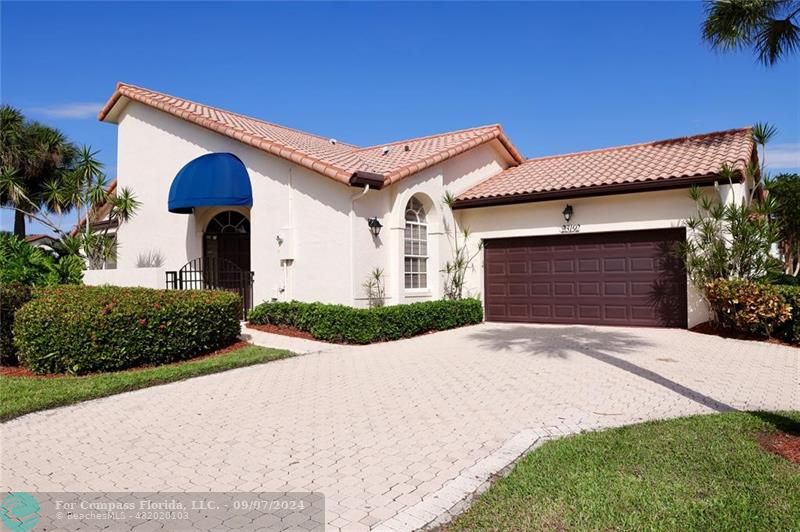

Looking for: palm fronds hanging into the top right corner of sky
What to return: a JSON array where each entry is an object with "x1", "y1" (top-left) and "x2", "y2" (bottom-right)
[{"x1": 703, "y1": 0, "x2": 800, "y2": 66}]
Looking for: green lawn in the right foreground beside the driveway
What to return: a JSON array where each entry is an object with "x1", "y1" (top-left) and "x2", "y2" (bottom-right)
[{"x1": 448, "y1": 412, "x2": 800, "y2": 531}]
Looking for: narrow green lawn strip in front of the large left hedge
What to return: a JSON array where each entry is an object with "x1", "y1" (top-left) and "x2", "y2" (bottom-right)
[{"x1": 0, "y1": 346, "x2": 293, "y2": 421}]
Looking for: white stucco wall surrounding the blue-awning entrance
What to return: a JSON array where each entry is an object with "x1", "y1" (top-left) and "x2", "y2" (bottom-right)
[{"x1": 117, "y1": 102, "x2": 352, "y2": 303}]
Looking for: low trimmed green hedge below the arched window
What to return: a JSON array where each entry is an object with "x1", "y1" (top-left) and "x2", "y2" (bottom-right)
[{"x1": 247, "y1": 299, "x2": 483, "y2": 344}]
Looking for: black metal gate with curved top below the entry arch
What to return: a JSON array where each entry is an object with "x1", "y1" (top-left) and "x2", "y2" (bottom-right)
[{"x1": 166, "y1": 257, "x2": 253, "y2": 317}]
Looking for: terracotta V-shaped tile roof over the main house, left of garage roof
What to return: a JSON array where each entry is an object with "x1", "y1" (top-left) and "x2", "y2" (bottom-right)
[{"x1": 98, "y1": 83, "x2": 524, "y2": 187}]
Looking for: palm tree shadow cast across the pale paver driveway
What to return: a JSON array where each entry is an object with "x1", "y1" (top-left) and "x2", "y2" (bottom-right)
[{"x1": 470, "y1": 325, "x2": 736, "y2": 412}]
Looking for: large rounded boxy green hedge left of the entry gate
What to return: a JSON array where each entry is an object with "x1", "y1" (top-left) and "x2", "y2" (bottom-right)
[{"x1": 14, "y1": 286, "x2": 241, "y2": 374}]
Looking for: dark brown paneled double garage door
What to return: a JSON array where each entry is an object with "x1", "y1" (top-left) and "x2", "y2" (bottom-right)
[{"x1": 484, "y1": 228, "x2": 686, "y2": 327}]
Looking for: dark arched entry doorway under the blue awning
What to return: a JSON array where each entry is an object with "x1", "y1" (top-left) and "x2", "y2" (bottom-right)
[{"x1": 203, "y1": 211, "x2": 250, "y2": 272}]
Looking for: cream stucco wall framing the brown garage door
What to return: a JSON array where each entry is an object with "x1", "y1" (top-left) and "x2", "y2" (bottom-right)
[{"x1": 457, "y1": 186, "x2": 730, "y2": 327}]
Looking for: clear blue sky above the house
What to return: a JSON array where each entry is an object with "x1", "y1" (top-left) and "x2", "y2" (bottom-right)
[{"x1": 0, "y1": 2, "x2": 800, "y2": 232}]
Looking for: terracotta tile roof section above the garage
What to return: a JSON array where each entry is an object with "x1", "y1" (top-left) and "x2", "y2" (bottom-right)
[{"x1": 456, "y1": 128, "x2": 756, "y2": 208}]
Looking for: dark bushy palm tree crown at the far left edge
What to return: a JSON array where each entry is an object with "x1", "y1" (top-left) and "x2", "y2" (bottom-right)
[{"x1": 0, "y1": 105, "x2": 76, "y2": 237}]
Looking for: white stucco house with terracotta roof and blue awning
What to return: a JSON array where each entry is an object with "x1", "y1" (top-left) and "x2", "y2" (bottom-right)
[{"x1": 86, "y1": 83, "x2": 756, "y2": 327}]
